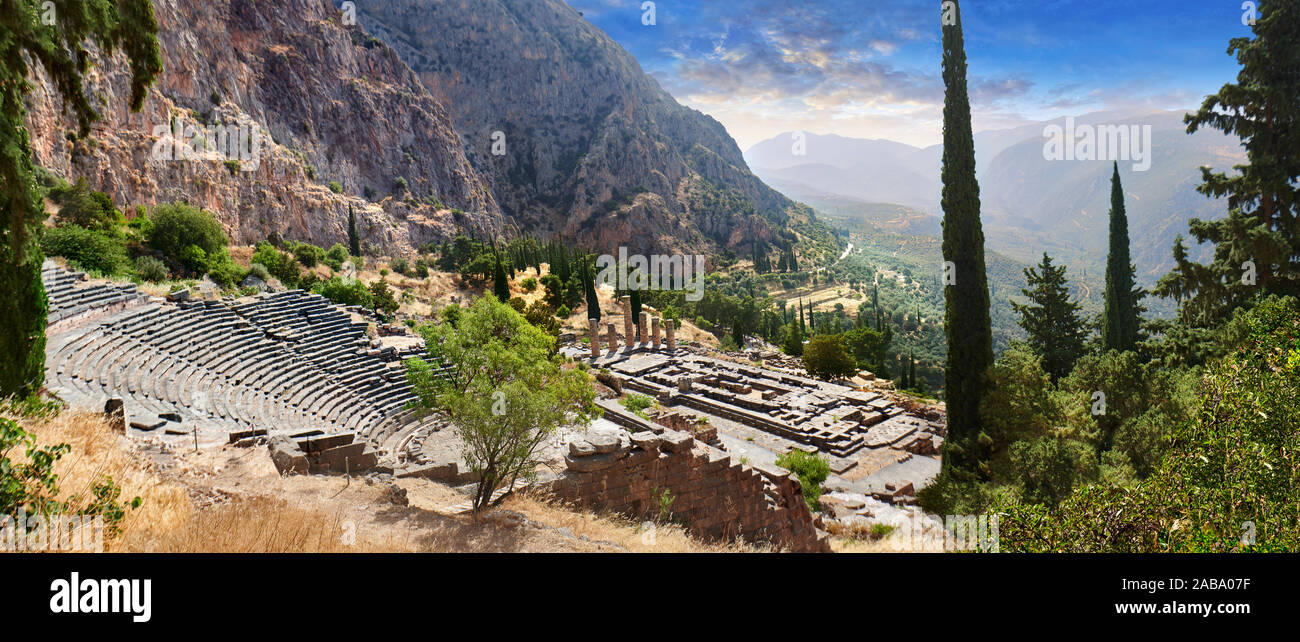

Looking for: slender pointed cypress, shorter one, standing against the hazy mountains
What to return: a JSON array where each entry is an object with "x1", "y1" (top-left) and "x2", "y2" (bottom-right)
[{"x1": 1101, "y1": 162, "x2": 1140, "y2": 352}]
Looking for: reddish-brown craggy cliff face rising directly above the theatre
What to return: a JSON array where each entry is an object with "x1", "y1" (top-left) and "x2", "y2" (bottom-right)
[{"x1": 29, "y1": 0, "x2": 502, "y2": 251}]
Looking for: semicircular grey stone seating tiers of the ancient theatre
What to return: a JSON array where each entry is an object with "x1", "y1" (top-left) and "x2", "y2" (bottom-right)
[{"x1": 43, "y1": 264, "x2": 452, "y2": 443}]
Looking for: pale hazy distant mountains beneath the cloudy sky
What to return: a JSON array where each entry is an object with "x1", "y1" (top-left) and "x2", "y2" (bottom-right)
[{"x1": 745, "y1": 112, "x2": 1245, "y2": 283}]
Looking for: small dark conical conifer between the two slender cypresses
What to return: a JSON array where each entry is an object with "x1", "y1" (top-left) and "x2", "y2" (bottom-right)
[{"x1": 1011, "y1": 252, "x2": 1087, "y2": 381}]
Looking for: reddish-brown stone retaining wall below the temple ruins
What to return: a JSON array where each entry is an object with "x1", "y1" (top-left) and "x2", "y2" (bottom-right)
[{"x1": 543, "y1": 430, "x2": 829, "y2": 552}]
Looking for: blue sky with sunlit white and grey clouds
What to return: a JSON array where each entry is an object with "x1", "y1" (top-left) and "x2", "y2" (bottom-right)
[{"x1": 567, "y1": 0, "x2": 1249, "y2": 149}]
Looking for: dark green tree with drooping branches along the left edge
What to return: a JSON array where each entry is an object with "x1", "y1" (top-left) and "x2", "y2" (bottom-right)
[{"x1": 0, "y1": 0, "x2": 163, "y2": 396}]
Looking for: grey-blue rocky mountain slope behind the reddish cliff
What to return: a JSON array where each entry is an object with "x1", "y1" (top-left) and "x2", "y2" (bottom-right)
[{"x1": 358, "y1": 0, "x2": 807, "y2": 252}]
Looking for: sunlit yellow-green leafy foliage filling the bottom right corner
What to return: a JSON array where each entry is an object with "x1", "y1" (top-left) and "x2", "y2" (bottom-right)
[{"x1": 996, "y1": 298, "x2": 1300, "y2": 552}]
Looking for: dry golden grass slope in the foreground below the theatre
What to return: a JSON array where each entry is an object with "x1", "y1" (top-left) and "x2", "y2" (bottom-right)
[{"x1": 10, "y1": 409, "x2": 757, "y2": 552}]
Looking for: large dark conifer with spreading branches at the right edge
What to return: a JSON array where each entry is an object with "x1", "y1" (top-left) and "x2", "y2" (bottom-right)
[{"x1": 1156, "y1": 0, "x2": 1300, "y2": 327}]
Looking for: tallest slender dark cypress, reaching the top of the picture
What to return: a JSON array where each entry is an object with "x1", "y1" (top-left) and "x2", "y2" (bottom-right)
[{"x1": 941, "y1": 0, "x2": 993, "y2": 480}]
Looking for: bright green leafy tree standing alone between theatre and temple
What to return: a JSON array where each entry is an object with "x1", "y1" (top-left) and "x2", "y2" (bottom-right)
[{"x1": 407, "y1": 296, "x2": 599, "y2": 517}]
